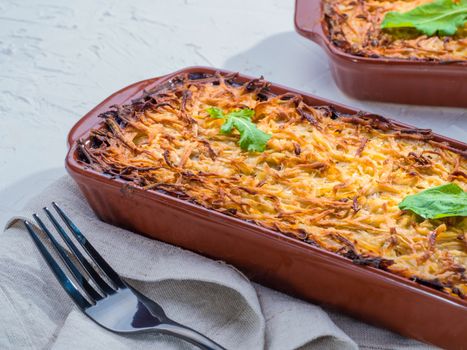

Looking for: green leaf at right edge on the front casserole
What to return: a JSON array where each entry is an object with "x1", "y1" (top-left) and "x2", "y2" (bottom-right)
[{"x1": 399, "y1": 183, "x2": 467, "y2": 219}]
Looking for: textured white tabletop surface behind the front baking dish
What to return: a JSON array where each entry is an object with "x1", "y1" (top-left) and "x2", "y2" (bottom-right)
[{"x1": 0, "y1": 0, "x2": 467, "y2": 214}]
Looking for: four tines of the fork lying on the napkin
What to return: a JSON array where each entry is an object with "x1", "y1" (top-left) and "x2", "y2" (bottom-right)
[{"x1": 24, "y1": 202, "x2": 126, "y2": 309}]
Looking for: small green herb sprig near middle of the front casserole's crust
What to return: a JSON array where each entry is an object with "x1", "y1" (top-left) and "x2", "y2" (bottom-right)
[{"x1": 207, "y1": 107, "x2": 271, "y2": 152}]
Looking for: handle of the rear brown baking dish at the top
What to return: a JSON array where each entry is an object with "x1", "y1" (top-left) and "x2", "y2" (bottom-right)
[{"x1": 295, "y1": 0, "x2": 325, "y2": 45}]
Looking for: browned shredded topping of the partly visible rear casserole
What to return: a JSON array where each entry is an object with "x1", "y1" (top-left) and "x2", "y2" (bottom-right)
[{"x1": 324, "y1": 0, "x2": 467, "y2": 61}]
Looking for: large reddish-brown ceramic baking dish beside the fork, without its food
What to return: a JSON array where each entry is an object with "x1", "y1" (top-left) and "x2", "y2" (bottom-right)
[{"x1": 66, "y1": 67, "x2": 467, "y2": 348}]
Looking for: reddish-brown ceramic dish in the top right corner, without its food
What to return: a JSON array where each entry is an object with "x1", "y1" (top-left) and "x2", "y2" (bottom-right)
[{"x1": 295, "y1": 0, "x2": 467, "y2": 107}]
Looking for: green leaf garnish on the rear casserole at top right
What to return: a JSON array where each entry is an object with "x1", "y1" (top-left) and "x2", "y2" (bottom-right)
[{"x1": 381, "y1": 0, "x2": 467, "y2": 36}]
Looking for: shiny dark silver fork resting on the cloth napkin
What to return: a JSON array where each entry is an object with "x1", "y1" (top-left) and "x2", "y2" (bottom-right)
[{"x1": 24, "y1": 202, "x2": 224, "y2": 350}]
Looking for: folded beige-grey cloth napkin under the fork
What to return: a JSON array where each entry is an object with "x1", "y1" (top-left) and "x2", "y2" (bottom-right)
[{"x1": 0, "y1": 176, "x2": 436, "y2": 350}]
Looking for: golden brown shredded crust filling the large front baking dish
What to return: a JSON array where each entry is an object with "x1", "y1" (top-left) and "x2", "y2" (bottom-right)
[{"x1": 80, "y1": 75, "x2": 467, "y2": 297}]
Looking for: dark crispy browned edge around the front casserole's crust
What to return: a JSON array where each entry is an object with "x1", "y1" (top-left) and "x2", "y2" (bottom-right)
[{"x1": 77, "y1": 73, "x2": 467, "y2": 299}]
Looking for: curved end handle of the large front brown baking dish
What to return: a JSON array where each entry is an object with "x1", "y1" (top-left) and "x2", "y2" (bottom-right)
[{"x1": 67, "y1": 75, "x2": 166, "y2": 149}]
